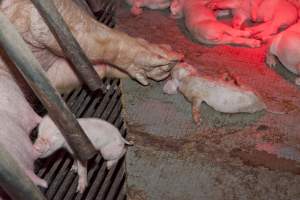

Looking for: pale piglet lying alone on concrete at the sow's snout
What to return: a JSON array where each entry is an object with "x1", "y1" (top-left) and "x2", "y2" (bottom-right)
[{"x1": 163, "y1": 63, "x2": 266, "y2": 125}]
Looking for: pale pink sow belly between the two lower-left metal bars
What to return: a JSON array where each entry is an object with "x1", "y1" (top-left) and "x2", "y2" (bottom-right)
[{"x1": 0, "y1": 69, "x2": 47, "y2": 187}]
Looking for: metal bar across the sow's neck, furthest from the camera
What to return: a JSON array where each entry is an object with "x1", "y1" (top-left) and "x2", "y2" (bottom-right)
[{"x1": 31, "y1": 0, "x2": 106, "y2": 93}]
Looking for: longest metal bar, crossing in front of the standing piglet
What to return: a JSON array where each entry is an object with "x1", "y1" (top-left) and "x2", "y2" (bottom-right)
[{"x1": 0, "y1": 11, "x2": 96, "y2": 161}]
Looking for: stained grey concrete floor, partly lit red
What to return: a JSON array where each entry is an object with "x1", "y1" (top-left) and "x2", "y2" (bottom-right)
[{"x1": 117, "y1": 5, "x2": 300, "y2": 200}]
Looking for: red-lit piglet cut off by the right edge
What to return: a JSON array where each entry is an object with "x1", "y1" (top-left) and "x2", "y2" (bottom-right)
[{"x1": 266, "y1": 22, "x2": 300, "y2": 85}]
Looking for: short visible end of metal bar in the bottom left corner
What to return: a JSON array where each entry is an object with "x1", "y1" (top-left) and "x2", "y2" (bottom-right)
[{"x1": 0, "y1": 142, "x2": 46, "y2": 200}]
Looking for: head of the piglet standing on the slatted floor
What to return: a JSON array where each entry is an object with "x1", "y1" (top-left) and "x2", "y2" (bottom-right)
[{"x1": 33, "y1": 116, "x2": 65, "y2": 158}]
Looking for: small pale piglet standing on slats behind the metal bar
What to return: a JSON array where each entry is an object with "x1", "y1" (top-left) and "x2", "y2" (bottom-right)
[{"x1": 33, "y1": 116, "x2": 132, "y2": 193}]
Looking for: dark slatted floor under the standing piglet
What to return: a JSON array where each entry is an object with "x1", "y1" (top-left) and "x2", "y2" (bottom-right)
[{"x1": 37, "y1": 79, "x2": 126, "y2": 200}]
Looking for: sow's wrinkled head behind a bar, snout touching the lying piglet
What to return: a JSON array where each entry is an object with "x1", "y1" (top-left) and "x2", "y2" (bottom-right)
[{"x1": 28, "y1": 0, "x2": 183, "y2": 85}]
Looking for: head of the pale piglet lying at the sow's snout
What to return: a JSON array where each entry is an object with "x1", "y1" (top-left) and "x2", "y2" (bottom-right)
[{"x1": 163, "y1": 63, "x2": 196, "y2": 94}]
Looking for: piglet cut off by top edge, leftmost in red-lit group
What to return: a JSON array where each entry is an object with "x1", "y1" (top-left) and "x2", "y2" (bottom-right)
[{"x1": 126, "y1": 0, "x2": 171, "y2": 15}]
